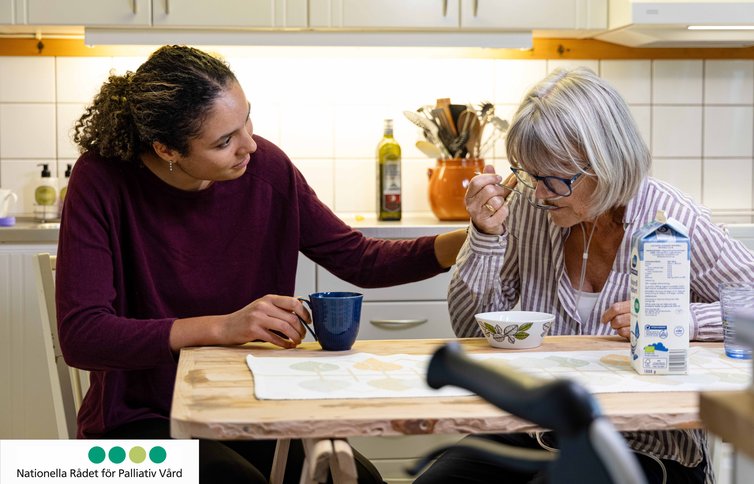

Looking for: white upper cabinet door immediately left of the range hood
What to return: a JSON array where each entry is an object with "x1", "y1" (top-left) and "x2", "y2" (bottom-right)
[{"x1": 460, "y1": 0, "x2": 607, "y2": 30}]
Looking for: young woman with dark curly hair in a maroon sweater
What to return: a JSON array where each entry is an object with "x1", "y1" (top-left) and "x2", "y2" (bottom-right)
[{"x1": 57, "y1": 46, "x2": 465, "y2": 483}]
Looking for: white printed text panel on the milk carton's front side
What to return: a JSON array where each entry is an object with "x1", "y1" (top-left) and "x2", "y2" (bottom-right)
[{"x1": 642, "y1": 242, "x2": 688, "y2": 317}]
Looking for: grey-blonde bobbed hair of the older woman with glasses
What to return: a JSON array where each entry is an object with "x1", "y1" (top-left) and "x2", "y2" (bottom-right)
[{"x1": 505, "y1": 67, "x2": 652, "y2": 217}]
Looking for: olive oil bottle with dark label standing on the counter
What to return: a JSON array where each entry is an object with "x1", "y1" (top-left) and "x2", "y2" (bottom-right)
[{"x1": 377, "y1": 119, "x2": 401, "y2": 220}]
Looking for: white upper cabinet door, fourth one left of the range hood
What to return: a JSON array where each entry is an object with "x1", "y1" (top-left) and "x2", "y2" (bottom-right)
[{"x1": 26, "y1": 0, "x2": 152, "y2": 26}]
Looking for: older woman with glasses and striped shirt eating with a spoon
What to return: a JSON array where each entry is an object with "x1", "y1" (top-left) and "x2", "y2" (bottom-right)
[{"x1": 420, "y1": 68, "x2": 754, "y2": 483}]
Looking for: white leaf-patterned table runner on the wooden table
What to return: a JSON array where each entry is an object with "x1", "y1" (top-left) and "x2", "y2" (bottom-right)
[{"x1": 246, "y1": 347, "x2": 751, "y2": 400}]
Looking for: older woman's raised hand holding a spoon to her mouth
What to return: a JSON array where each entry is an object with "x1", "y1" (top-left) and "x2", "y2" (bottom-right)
[{"x1": 466, "y1": 165, "x2": 516, "y2": 235}]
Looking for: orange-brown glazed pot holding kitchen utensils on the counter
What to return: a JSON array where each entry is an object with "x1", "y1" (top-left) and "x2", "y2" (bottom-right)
[{"x1": 427, "y1": 158, "x2": 484, "y2": 220}]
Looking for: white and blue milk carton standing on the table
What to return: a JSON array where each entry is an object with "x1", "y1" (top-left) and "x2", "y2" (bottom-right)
[{"x1": 630, "y1": 211, "x2": 691, "y2": 374}]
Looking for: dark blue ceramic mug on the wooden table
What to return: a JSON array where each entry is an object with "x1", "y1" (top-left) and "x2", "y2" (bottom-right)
[{"x1": 299, "y1": 292, "x2": 364, "y2": 351}]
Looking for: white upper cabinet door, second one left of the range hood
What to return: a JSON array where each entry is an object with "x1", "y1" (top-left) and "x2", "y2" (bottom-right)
[{"x1": 309, "y1": 0, "x2": 458, "y2": 30}]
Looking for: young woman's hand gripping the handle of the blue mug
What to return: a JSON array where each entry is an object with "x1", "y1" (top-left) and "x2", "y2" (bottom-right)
[{"x1": 221, "y1": 294, "x2": 311, "y2": 348}]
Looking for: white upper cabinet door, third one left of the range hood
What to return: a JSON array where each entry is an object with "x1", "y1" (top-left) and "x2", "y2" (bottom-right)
[{"x1": 152, "y1": 0, "x2": 308, "y2": 28}]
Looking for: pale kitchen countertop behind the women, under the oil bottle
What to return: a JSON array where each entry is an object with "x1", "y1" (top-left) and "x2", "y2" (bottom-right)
[{"x1": 0, "y1": 213, "x2": 468, "y2": 244}]
